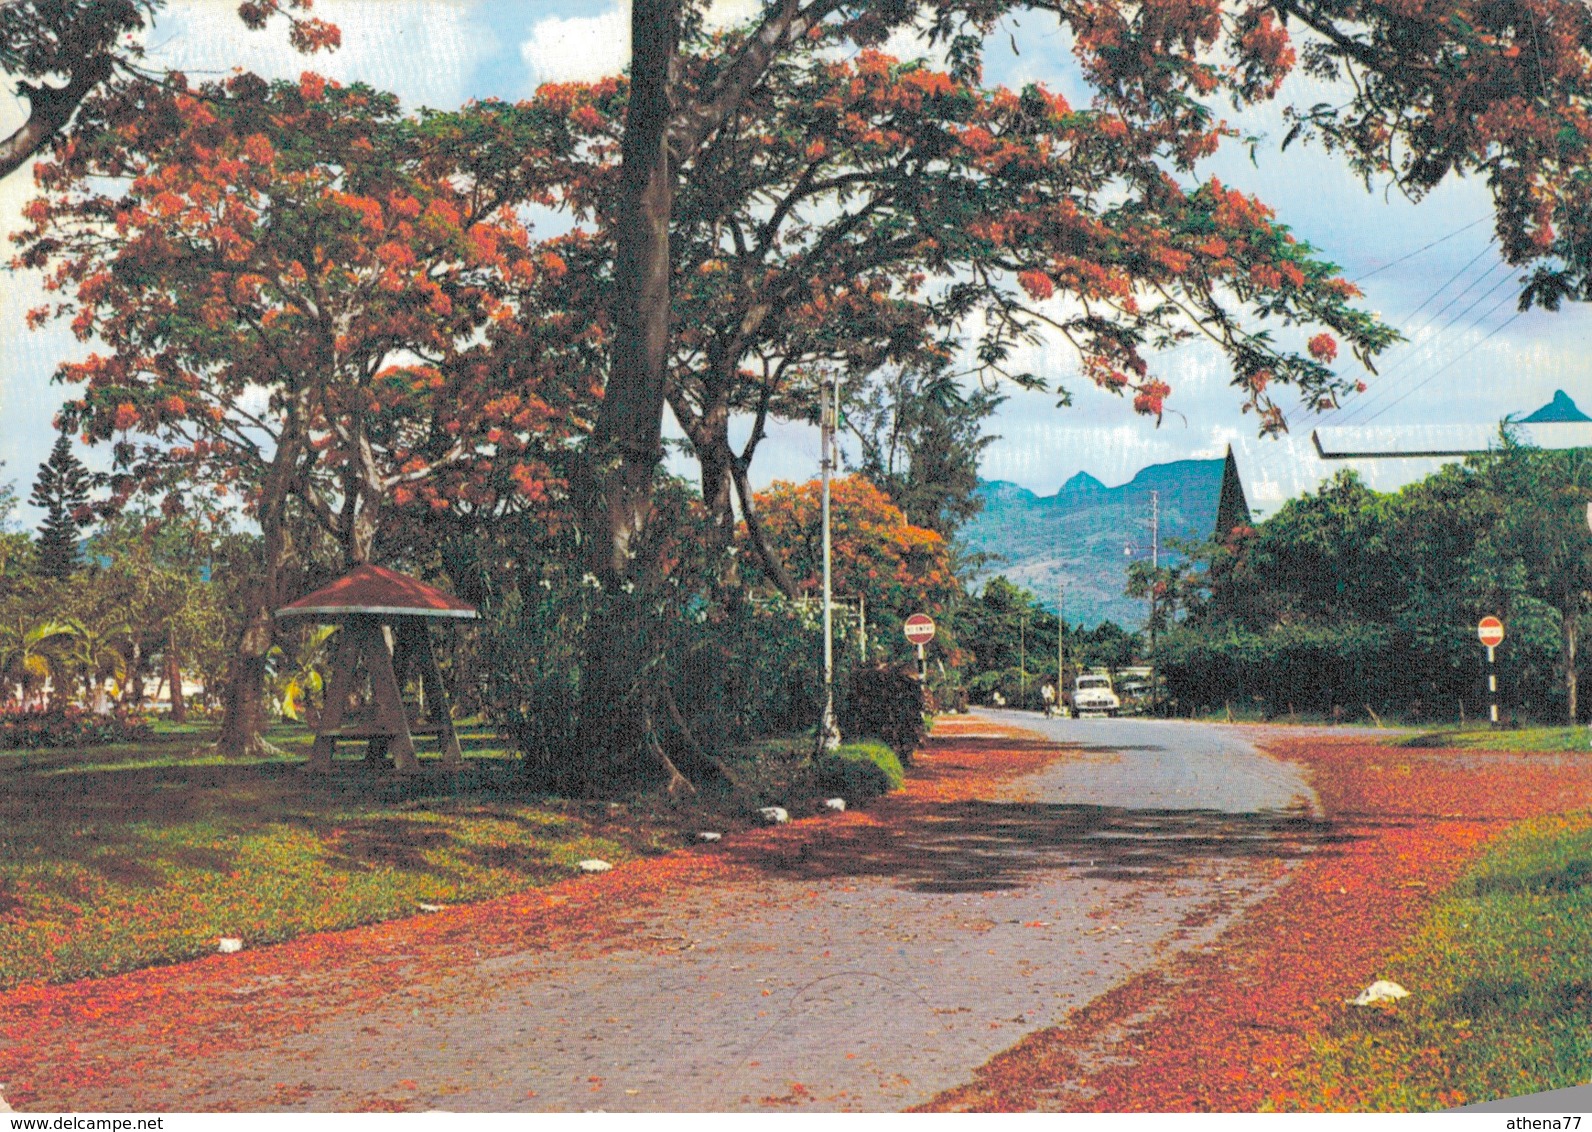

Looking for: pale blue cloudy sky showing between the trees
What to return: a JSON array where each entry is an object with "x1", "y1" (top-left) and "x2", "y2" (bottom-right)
[{"x1": 0, "y1": 0, "x2": 1592, "y2": 522}]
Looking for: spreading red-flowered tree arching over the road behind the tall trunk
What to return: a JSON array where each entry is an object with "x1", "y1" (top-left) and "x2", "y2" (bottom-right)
[{"x1": 490, "y1": 33, "x2": 1393, "y2": 591}]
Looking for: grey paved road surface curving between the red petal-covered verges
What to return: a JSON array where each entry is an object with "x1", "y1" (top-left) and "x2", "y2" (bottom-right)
[{"x1": 185, "y1": 712, "x2": 1313, "y2": 1110}]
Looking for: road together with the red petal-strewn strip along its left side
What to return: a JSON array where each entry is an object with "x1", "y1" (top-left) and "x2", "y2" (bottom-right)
[{"x1": 0, "y1": 720, "x2": 1318, "y2": 1110}]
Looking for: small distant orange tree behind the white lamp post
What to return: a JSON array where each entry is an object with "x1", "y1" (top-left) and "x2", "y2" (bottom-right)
[{"x1": 756, "y1": 476, "x2": 960, "y2": 643}]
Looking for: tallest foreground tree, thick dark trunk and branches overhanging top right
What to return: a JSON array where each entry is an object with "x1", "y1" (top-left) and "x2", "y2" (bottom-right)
[{"x1": 587, "y1": 0, "x2": 1592, "y2": 601}]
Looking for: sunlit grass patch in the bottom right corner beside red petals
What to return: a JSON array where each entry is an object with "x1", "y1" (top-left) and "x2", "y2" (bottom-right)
[{"x1": 1288, "y1": 812, "x2": 1592, "y2": 1111}]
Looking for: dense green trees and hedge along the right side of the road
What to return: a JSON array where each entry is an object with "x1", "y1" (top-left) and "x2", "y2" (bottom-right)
[{"x1": 1184, "y1": 445, "x2": 1592, "y2": 718}]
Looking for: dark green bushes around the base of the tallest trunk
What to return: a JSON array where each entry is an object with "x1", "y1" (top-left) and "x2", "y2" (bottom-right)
[{"x1": 474, "y1": 482, "x2": 856, "y2": 793}]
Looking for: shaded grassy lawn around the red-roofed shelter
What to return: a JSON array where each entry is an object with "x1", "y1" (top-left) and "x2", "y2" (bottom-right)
[{"x1": 0, "y1": 726, "x2": 703, "y2": 987}]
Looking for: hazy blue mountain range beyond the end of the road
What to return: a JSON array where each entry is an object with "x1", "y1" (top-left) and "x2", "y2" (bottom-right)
[{"x1": 962, "y1": 459, "x2": 1223, "y2": 627}]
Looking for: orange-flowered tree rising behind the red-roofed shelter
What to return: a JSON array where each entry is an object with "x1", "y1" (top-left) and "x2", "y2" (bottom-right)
[{"x1": 18, "y1": 73, "x2": 592, "y2": 750}]
